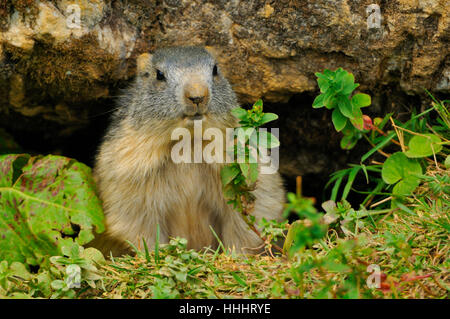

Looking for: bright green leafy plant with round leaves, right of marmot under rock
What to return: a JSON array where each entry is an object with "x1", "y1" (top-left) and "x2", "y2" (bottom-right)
[{"x1": 313, "y1": 68, "x2": 449, "y2": 207}]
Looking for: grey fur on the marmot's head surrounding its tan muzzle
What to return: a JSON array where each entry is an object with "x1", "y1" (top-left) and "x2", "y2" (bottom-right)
[{"x1": 114, "y1": 47, "x2": 238, "y2": 127}]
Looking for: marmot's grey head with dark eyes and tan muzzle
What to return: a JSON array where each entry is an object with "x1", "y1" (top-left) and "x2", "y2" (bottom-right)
[{"x1": 121, "y1": 47, "x2": 237, "y2": 126}]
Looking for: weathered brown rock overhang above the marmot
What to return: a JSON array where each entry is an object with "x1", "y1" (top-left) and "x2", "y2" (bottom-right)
[{"x1": 0, "y1": 0, "x2": 450, "y2": 185}]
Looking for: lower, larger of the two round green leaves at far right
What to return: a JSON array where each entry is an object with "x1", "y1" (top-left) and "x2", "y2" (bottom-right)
[{"x1": 381, "y1": 152, "x2": 422, "y2": 195}]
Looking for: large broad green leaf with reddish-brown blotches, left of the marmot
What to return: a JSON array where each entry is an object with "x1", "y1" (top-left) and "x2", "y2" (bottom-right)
[{"x1": 0, "y1": 154, "x2": 104, "y2": 265}]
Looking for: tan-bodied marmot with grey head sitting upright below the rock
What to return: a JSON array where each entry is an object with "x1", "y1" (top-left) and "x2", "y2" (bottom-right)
[{"x1": 93, "y1": 47, "x2": 285, "y2": 255}]
